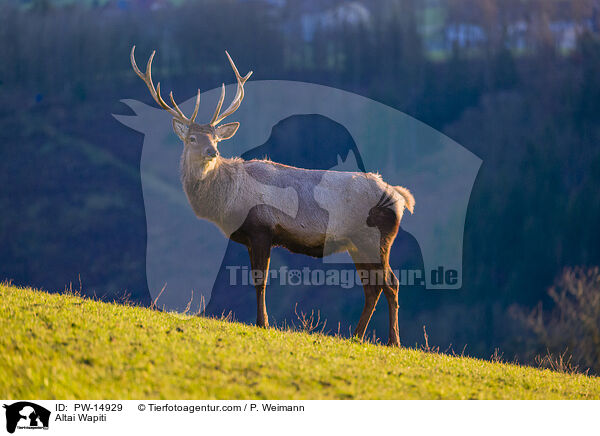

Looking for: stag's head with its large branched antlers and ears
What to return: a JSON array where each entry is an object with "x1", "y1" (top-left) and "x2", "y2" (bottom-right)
[{"x1": 130, "y1": 45, "x2": 252, "y2": 166}]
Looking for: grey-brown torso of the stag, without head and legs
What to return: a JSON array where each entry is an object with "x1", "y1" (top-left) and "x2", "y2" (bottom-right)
[{"x1": 181, "y1": 156, "x2": 406, "y2": 257}]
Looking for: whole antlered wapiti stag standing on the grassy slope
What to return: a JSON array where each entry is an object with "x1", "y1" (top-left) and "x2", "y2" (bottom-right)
[{"x1": 131, "y1": 46, "x2": 414, "y2": 346}]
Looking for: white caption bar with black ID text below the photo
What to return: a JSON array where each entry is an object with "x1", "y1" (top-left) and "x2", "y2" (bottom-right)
[{"x1": 0, "y1": 400, "x2": 600, "y2": 436}]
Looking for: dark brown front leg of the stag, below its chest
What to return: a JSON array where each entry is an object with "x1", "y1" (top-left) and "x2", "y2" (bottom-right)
[{"x1": 248, "y1": 235, "x2": 271, "y2": 328}]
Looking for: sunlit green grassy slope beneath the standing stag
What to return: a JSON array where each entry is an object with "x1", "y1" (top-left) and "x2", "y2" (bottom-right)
[{"x1": 0, "y1": 285, "x2": 600, "y2": 399}]
